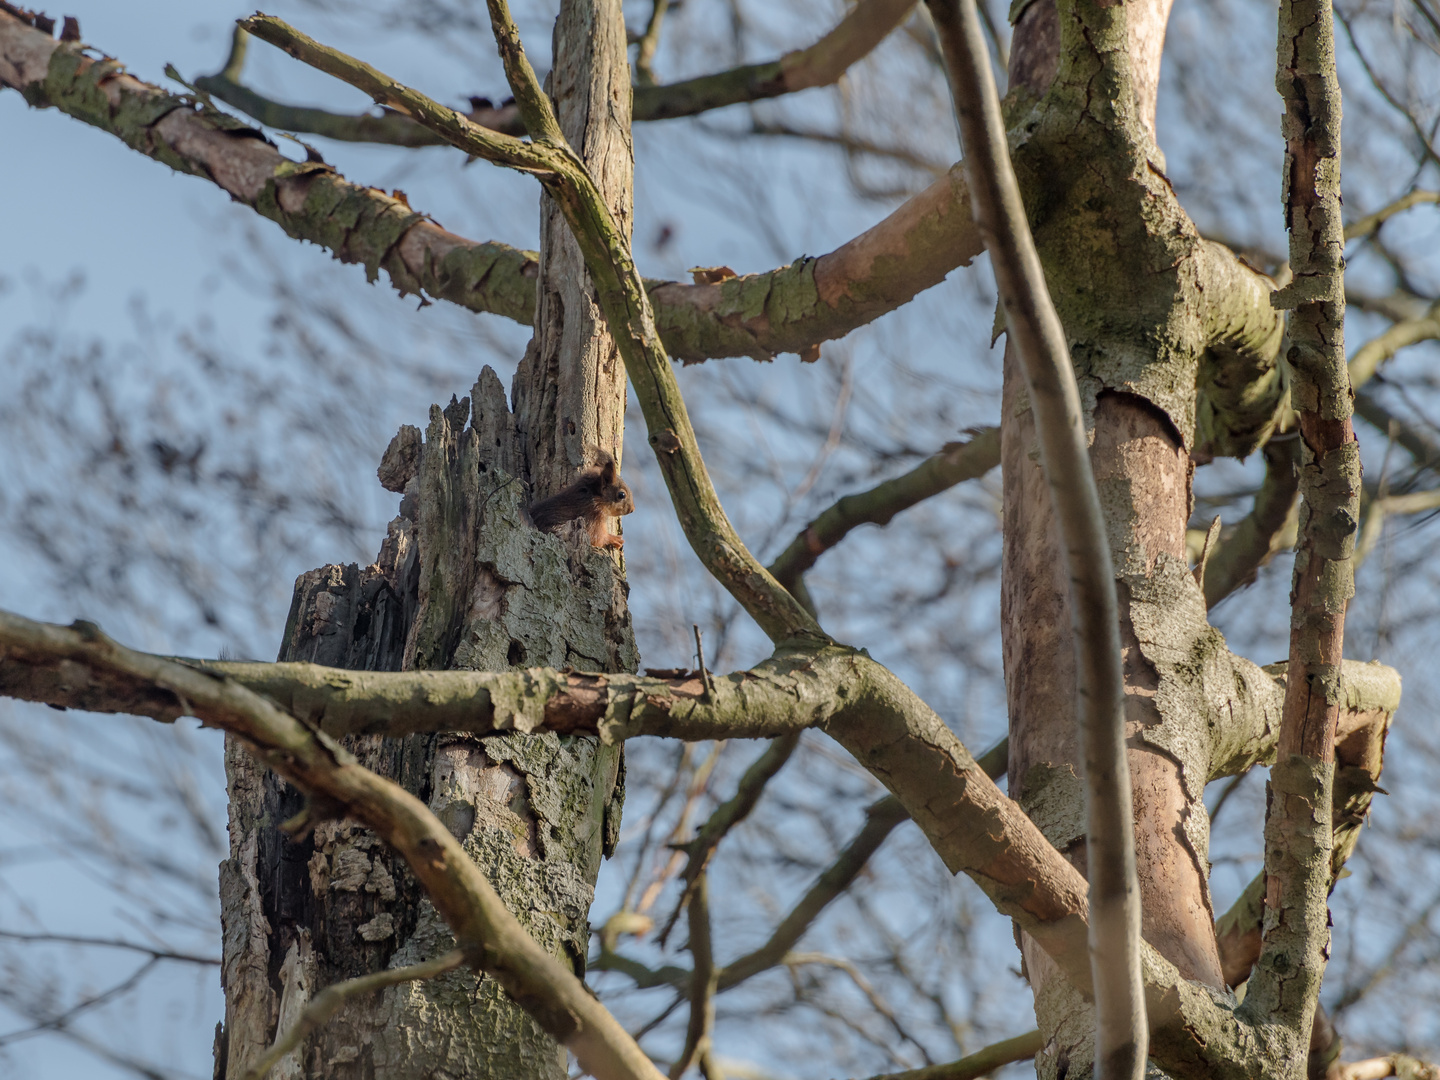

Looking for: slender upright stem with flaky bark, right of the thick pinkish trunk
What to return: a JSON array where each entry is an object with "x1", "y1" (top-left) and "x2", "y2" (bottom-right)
[{"x1": 1243, "y1": 0, "x2": 1361, "y2": 1048}]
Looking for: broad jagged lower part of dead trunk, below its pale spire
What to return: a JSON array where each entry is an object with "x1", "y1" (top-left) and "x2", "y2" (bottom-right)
[{"x1": 222, "y1": 369, "x2": 635, "y2": 1080}]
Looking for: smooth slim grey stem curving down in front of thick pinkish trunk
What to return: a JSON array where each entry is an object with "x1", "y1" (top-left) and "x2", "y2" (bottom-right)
[{"x1": 927, "y1": 0, "x2": 1149, "y2": 1080}]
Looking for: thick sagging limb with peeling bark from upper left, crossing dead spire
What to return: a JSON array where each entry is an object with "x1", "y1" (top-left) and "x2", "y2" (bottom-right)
[{"x1": 0, "y1": 10, "x2": 982, "y2": 363}]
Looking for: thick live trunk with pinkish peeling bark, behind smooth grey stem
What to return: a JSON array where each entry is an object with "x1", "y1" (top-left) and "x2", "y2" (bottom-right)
[{"x1": 1001, "y1": 0, "x2": 1280, "y2": 1079}]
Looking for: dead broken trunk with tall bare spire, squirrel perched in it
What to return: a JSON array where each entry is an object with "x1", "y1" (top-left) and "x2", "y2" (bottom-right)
[{"x1": 216, "y1": 0, "x2": 638, "y2": 1080}]
